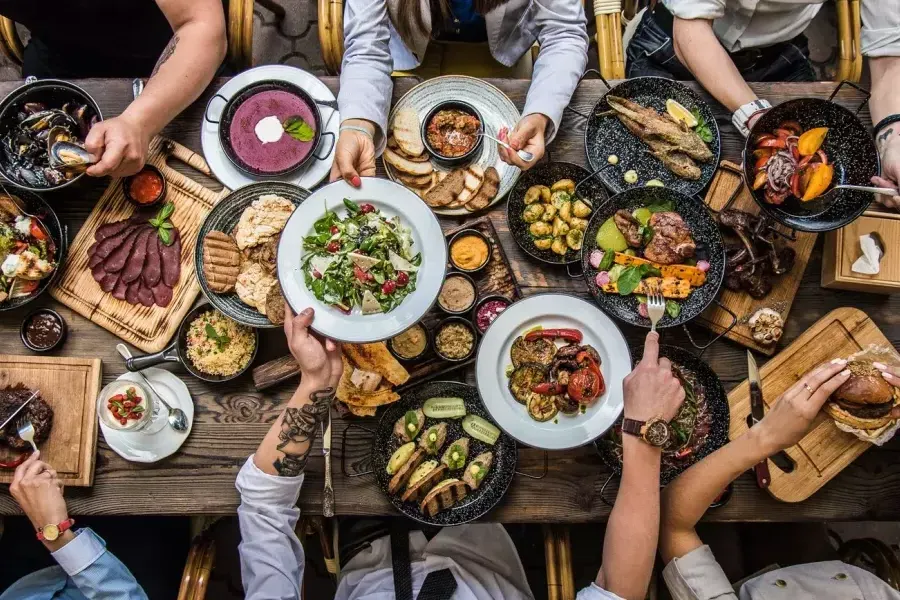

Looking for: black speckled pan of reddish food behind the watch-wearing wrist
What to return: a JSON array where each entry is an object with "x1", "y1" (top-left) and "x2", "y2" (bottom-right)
[{"x1": 594, "y1": 346, "x2": 730, "y2": 485}]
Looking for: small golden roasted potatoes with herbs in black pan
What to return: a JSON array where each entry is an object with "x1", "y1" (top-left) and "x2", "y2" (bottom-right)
[{"x1": 522, "y1": 179, "x2": 592, "y2": 256}]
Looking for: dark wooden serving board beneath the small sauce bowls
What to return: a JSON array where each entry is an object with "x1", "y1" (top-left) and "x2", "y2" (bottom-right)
[{"x1": 253, "y1": 216, "x2": 522, "y2": 391}]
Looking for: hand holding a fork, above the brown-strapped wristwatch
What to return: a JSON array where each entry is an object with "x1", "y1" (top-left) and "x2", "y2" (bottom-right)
[{"x1": 625, "y1": 332, "x2": 684, "y2": 421}]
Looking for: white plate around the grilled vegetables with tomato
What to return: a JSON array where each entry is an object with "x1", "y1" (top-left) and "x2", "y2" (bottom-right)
[{"x1": 475, "y1": 294, "x2": 631, "y2": 450}]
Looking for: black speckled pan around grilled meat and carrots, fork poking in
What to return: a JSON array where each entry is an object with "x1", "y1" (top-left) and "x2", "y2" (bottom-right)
[{"x1": 581, "y1": 187, "x2": 725, "y2": 328}]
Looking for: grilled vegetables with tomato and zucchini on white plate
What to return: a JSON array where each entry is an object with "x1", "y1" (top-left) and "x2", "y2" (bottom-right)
[{"x1": 508, "y1": 328, "x2": 606, "y2": 422}]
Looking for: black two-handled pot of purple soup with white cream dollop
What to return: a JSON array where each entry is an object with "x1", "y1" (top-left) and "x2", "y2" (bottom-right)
[{"x1": 205, "y1": 80, "x2": 335, "y2": 177}]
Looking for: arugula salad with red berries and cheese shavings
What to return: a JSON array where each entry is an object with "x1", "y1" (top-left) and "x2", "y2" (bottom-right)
[{"x1": 301, "y1": 198, "x2": 422, "y2": 315}]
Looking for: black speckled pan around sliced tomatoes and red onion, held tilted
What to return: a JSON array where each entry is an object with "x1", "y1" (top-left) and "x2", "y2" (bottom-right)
[{"x1": 744, "y1": 98, "x2": 879, "y2": 232}]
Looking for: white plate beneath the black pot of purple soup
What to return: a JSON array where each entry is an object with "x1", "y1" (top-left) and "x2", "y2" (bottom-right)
[{"x1": 200, "y1": 65, "x2": 341, "y2": 190}]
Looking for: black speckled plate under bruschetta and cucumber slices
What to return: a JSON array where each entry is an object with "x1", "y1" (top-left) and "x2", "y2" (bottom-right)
[{"x1": 372, "y1": 381, "x2": 518, "y2": 526}]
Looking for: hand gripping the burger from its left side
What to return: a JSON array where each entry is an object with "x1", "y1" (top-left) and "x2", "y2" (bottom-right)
[{"x1": 751, "y1": 358, "x2": 850, "y2": 456}]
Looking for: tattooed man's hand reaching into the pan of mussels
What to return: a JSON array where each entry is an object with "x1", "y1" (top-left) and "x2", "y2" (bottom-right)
[{"x1": 84, "y1": 112, "x2": 151, "y2": 177}]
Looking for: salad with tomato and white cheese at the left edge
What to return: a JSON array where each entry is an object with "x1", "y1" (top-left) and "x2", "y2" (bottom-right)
[{"x1": 0, "y1": 195, "x2": 57, "y2": 306}]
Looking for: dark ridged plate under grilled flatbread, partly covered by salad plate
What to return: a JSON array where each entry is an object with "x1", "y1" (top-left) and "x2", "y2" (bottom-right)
[{"x1": 194, "y1": 181, "x2": 309, "y2": 328}]
